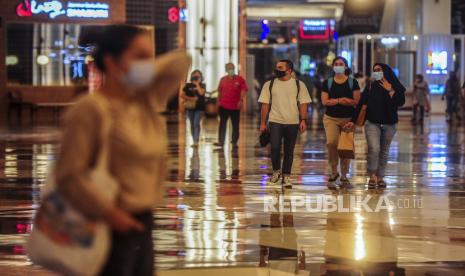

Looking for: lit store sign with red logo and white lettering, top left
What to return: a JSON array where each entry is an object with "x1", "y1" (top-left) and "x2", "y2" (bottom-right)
[{"x1": 16, "y1": 0, "x2": 110, "y2": 19}]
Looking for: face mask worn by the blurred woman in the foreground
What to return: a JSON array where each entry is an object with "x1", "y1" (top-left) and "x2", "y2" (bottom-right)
[{"x1": 123, "y1": 59, "x2": 155, "y2": 89}]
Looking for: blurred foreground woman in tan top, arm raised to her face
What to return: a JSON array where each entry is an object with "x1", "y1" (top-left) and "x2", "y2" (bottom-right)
[{"x1": 55, "y1": 25, "x2": 190, "y2": 276}]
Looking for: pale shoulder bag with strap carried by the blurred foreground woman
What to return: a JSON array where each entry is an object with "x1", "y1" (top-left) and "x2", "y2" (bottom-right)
[{"x1": 26, "y1": 96, "x2": 118, "y2": 275}]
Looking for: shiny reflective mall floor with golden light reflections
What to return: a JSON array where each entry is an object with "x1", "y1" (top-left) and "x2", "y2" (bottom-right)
[{"x1": 0, "y1": 111, "x2": 465, "y2": 276}]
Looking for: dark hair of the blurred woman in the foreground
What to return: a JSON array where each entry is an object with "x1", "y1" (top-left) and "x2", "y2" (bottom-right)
[{"x1": 93, "y1": 25, "x2": 146, "y2": 72}]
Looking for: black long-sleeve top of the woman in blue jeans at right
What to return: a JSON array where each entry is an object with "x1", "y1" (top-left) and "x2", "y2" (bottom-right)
[{"x1": 352, "y1": 82, "x2": 405, "y2": 125}]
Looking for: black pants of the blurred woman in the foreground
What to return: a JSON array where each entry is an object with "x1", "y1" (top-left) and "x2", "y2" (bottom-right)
[{"x1": 101, "y1": 212, "x2": 154, "y2": 276}]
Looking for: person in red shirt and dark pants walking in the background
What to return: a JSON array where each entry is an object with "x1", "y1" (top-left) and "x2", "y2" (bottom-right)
[{"x1": 215, "y1": 63, "x2": 248, "y2": 147}]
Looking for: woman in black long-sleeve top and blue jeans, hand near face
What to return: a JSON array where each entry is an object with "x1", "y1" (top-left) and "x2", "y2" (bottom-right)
[{"x1": 346, "y1": 63, "x2": 405, "y2": 189}]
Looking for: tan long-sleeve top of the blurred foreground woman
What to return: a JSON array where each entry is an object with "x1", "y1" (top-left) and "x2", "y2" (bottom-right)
[{"x1": 55, "y1": 51, "x2": 190, "y2": 218}]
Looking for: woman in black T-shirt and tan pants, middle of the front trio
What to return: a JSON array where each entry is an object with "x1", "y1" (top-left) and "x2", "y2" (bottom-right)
[{"x1": 321, "y1": 57, "x2": 360, "y2": 189}]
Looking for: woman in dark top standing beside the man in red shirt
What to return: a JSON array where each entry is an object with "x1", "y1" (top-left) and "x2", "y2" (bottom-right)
[{"x1": 181, "y1": 70, "x2": 206, "y2": 147}]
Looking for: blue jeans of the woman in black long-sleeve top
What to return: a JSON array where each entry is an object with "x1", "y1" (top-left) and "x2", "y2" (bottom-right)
[{"x1": 365, "y1": 121, "x2": 397, "y2": 177}]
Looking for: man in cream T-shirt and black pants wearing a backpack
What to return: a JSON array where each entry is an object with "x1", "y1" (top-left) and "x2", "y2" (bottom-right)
[{"x1": 258, "y1": 60, "x2": 311, "y2": 188}]
